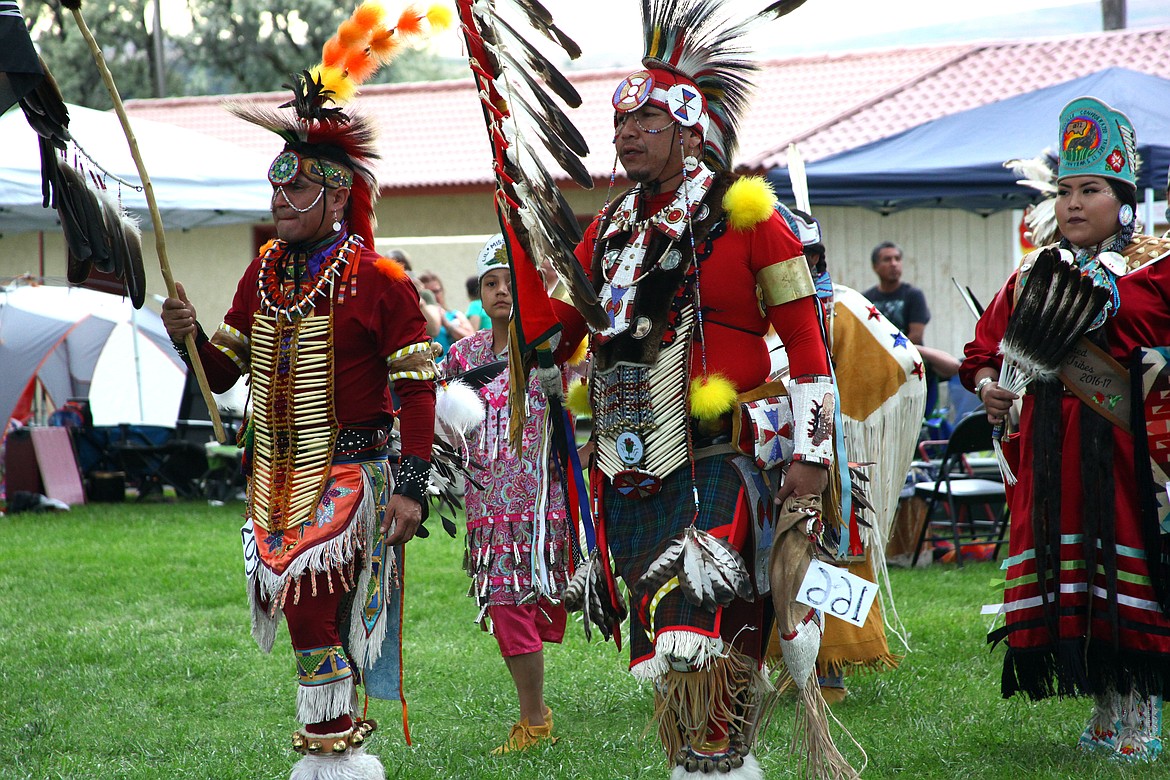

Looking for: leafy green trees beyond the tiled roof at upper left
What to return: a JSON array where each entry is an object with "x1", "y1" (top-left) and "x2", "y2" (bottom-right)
[{"x1": 26, "y1": 0, "x2": 467, "y2": 109}]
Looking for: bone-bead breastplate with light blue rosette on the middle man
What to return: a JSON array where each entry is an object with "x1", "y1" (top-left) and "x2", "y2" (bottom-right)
[{"x1": 592, "y1": 306, "x2": 694, "y2": 482}]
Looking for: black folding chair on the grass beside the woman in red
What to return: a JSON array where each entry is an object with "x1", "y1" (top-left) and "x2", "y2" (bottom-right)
[{"x1": 913, "y1": 409, "x2": 1007, "y2": 566}]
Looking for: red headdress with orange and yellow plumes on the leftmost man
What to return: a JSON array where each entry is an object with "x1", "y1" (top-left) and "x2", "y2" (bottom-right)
[{"x1": 227, "y1": 0, "x2": 454, "y2": 247}]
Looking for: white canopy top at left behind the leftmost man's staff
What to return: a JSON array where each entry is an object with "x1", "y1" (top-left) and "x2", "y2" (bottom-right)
[{"x1": 0, "y1": 105, "x2": 271, "y2": 233}]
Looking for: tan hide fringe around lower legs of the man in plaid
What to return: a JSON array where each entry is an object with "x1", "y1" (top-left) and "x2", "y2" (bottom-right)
[{"x1": 654, "y1": 651, "x2": 776, "y2": 766}]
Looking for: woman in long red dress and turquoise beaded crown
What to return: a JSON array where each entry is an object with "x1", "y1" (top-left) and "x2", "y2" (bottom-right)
[{"x1": 961, "y1": 97, "x2": 1170, "y2": 761}]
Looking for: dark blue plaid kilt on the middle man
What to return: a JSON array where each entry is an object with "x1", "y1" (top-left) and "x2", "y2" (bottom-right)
[{"x1": 601, "y1": 455, "x2": 771, "y2": 667}]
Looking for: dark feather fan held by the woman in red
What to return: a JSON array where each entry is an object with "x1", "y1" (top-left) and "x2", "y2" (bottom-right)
[{"x1": 995, "y1": 247, "x2": 1109, "y2": 484}]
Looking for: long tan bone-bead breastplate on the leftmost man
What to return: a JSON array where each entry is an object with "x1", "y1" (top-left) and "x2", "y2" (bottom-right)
[{"x1": 250, "y1": 313, "x2": 337, "y2": 532}]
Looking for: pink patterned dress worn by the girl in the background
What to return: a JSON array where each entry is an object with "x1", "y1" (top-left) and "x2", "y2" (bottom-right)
[{"x1": 443, "y1": 330, "x2": 570, "y2": 620}]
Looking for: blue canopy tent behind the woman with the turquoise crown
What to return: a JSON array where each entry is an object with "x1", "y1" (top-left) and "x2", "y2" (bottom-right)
[{"x1": 768, "y1": 68, "x2": 1170, "y2": 213}]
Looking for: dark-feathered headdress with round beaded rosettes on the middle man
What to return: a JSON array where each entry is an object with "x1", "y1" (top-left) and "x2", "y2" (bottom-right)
[{"x1": 613, "y1": 0, "x2": 805, "y2": 171}]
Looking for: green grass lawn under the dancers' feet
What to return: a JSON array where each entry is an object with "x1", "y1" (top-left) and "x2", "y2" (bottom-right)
[{"x1": 0, "y1": 503, "x2": 1170, "y2": 780}]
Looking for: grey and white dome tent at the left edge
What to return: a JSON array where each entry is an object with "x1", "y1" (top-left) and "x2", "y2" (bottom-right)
[{"x1": 0, "y1": 285, "x2": 187, "y2": 428}]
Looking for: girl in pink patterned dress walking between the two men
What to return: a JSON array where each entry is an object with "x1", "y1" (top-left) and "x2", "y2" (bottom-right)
[{"x1": 443, "y1": 235, "x2": 571, "y2": 754}]
